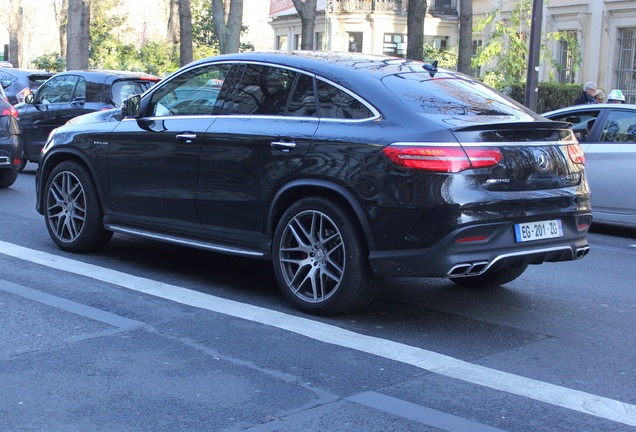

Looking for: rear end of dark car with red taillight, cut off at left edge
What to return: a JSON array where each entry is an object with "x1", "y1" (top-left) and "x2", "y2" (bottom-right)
[{"x1": 0, "y1": 99, "x2": 23, "y2": 188}]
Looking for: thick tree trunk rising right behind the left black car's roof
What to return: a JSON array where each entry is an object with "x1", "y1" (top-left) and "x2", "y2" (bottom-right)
[{"x1": 66, "y1": 0, "x2": 90, "y2": 70}]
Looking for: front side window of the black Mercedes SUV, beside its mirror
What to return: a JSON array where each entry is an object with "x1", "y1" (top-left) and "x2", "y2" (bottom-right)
[{"x1": 148, "y1": 64, "x2": 232, "y2": 116}]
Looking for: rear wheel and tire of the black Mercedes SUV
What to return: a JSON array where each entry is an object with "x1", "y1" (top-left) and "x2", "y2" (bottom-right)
[{"x1": 272, "y1": 197, "x2": 378, "y2": 315}]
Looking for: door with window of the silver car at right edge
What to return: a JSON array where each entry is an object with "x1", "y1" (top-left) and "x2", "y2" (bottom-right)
[{"x1": 583, "y1": 108, "x2": 636, "y2": 216}]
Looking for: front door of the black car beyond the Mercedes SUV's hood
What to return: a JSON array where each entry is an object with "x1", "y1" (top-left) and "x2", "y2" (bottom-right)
[{"x1": 19, "y1": 74, "x2": 83, "y2": 159}]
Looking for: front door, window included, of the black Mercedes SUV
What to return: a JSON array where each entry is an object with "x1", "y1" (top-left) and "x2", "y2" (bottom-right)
[{"x1": 108, "y1": 65, "x2": 234, "y2": 229}]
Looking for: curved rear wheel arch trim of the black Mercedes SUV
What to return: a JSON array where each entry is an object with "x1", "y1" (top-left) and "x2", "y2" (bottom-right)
[{"x1": 266, "y1": 180, "x2": 375, "y2": 250}]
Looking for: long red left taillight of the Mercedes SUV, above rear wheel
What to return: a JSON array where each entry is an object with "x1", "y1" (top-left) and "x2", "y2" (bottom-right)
[{"x1": 382, "y1": 145, "x2": 501, "y2": 173}]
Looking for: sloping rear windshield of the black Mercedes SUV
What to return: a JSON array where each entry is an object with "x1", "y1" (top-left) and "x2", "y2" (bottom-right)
[{"x1": 382, "y1": 73, "x2": 529, "y2": 117}]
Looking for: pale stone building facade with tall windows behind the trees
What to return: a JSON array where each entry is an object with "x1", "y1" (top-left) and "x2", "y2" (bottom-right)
[{"x1": 268, "y1": 0, "x2": 636, "y2": 103}]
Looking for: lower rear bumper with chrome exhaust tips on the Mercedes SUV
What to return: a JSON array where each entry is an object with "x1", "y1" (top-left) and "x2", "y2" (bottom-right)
[{"x1": 369, "y1": 213, "x2": 592, "y2": 277}]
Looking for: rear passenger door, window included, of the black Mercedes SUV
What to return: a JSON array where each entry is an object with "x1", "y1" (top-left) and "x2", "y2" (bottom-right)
[{"x1": 197, "y1": 64, "x2": 319, "y2": 242}]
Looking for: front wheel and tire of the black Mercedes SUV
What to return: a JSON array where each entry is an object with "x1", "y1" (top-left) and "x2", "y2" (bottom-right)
[{"x1": 44, "y1": 161, "x2": 113, "y2": 252}]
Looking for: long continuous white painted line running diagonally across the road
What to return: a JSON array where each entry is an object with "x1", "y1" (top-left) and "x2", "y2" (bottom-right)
[{"x1": 0, "y1": 241, "x2": 636, "y2": 426}]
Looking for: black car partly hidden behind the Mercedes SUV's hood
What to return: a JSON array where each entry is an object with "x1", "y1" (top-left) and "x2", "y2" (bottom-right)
[{"x1": 16, "y1": 70, "x2": 159, "y2": 166}]
